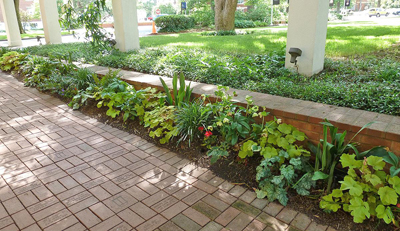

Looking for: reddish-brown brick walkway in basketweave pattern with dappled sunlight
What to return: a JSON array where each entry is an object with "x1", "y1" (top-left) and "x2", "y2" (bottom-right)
[{"x1": 0, "y1": 73, "x2": 333, "y2": 231}]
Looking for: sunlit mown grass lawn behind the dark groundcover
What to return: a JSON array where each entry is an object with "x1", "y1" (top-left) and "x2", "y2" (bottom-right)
[{"x1": 140, "y1": 24, "x2": 400, "y2": 57}]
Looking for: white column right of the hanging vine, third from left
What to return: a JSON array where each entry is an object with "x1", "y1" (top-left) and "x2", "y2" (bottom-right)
[{"x1": 112, "y1": 0, "x2": 140, "y2": 52}]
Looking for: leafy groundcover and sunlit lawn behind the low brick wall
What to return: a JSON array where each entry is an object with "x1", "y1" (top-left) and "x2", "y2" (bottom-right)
[{"x1": 23, "y1": 25, "x2": 400, "y2": 115}]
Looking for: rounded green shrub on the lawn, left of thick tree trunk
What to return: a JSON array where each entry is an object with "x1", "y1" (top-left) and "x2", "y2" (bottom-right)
[{"x1": 155, "y1": 15, "x2": 195, "y2": 32}]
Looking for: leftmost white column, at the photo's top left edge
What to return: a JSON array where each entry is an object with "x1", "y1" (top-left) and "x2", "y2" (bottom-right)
[{"x1": 0, "y1": 0, "x2": 22, "y2": 46}]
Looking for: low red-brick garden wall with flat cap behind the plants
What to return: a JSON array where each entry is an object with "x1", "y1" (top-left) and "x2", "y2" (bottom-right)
[{"x1": 78, "y1": 63, "x2": 400, "y2": 156}]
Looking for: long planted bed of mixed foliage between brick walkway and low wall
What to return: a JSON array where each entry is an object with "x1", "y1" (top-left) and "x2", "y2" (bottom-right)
[{"x1": 0, "y1": 46, "x2": 400, "y2": 230}]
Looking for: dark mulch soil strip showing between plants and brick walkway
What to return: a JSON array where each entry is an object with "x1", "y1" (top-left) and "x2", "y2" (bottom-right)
[{"x1": 10, "y1": 65, "x2": 395, "y2": 231}]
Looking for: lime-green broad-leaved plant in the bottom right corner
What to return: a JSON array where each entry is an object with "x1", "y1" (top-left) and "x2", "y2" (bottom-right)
[{"x1": 320, "y1": 154, "x2": 400, "y2": 226}]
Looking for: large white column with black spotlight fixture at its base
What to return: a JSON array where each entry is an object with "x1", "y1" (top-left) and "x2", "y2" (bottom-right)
[{"x1": 285, "y1": 0, "x2": 329, "y2": 76}]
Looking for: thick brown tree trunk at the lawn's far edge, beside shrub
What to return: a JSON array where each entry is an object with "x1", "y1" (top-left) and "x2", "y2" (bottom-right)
[{"x1": 214, "y1": 0, "x2": 238, "y2": 31}]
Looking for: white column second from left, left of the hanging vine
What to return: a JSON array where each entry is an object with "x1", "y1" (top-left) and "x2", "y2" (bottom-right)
[{"x1": 39, "y1": 0, "x2": 62, "y2": 44}]
